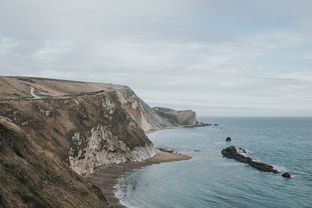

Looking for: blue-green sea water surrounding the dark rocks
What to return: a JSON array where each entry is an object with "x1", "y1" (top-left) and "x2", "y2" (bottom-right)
[{"x1": 117, "y1": 118, "x2": 312, "y2": 208}]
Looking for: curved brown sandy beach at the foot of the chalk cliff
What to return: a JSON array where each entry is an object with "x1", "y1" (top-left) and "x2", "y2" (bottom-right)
[{"x1": 87, "y1": 152, "x2": 192, "y2": 208}]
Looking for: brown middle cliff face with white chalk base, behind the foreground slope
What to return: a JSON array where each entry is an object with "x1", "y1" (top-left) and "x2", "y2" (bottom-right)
[{"x1": 0, "y1": 91, "x2": 155, "y2": 174}]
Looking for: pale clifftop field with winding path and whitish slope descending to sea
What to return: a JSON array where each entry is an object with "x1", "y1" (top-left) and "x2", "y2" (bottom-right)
[{"x1": 0, "y1": 76, "x2": 172, "y2": 132}]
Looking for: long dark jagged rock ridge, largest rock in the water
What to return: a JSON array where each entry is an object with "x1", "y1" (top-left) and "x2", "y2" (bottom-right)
[{"x1": 221, "y1": 146, "x2": 278, "y2": 173}]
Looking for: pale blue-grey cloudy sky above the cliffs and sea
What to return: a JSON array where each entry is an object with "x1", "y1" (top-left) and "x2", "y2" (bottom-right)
[{"x1": 0, "y1": 0, "x2": 312, "y2": 116}]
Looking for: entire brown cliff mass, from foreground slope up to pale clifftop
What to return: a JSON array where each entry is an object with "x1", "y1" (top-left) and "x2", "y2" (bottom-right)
[{"x1": 0, "y1": 77, "x2": 199, "y2": 207}]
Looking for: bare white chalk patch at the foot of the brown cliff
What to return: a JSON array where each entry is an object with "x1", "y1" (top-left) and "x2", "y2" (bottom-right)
[{"x1": 69, "y1": 124, "x2": 156, "y2": 174}]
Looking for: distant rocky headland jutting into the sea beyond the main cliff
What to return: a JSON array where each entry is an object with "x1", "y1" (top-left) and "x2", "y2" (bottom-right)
[{"x1": 153, "y1": 107, "x2": 197, "y2": 126}]
